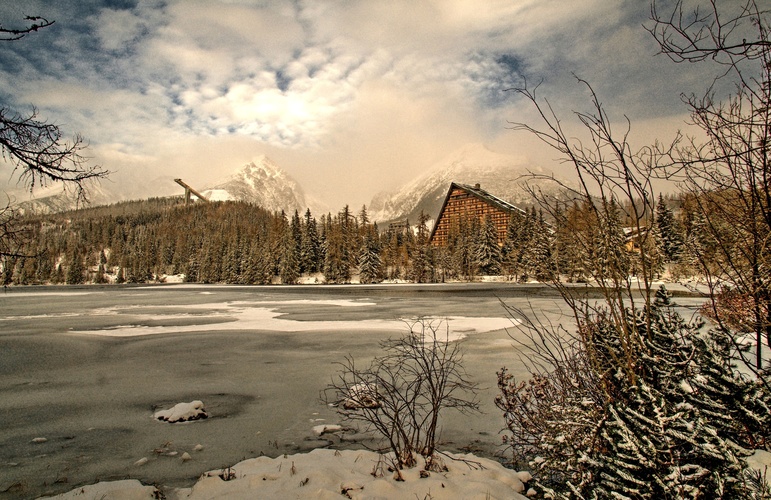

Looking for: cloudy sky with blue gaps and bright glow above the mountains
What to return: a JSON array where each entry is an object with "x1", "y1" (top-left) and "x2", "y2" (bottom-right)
[{"x1": 0, "y1": 0, "x2": 728, "y2": 207}]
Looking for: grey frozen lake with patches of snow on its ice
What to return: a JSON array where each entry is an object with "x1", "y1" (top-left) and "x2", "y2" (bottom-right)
[{"x1": 0, "y1": 284, "x2": 697, "y2": 498}]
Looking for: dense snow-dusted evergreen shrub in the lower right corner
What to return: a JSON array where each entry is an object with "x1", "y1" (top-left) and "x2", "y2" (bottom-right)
[{"x1": 496, "y1": 290, "x2": 768, "y2": 498}]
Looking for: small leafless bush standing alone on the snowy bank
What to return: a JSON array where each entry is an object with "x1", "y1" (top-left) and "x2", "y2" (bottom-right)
[{"x1": 322, "y1": 319, "x2": 479, "y2": 469}]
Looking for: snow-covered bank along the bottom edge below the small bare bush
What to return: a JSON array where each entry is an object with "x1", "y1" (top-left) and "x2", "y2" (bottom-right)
[{"x1": 48, "y1": 449, "x2": 530, "y2": 500}]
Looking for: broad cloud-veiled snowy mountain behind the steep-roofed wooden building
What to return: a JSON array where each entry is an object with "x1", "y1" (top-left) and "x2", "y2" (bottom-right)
[{"x1": 369, "y1": 144, "x2": 559, "y2": 223}]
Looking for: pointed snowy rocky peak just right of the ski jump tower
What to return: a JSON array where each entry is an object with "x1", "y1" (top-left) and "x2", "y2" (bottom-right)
[{"x1": 201, "y1": 156, "x2": 308, "y2": 214}]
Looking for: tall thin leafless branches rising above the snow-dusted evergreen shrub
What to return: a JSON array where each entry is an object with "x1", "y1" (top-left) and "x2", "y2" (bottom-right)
[{"x1": 511, "y1": 78, "x2": 657, "y2": 383}]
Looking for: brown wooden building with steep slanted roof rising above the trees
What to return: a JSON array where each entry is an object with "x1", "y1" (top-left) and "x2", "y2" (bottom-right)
[{"x1": 430, "y1": 182, "x2": 525, "y2": 246}]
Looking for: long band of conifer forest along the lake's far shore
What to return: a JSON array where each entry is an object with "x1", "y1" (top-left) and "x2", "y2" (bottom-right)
[{"x1": 1, "y1": 188, "x2": 699, "y2": 285}]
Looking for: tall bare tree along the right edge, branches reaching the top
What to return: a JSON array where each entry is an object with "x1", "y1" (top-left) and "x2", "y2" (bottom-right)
[{"x1": 648, "y1": 0, "x2": 771, "y2": 370}]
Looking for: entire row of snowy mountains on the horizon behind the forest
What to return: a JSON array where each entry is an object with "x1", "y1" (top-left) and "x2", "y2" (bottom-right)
[{"x1": 7, "y1": 143, "x2": 568, "y2": 219}]
